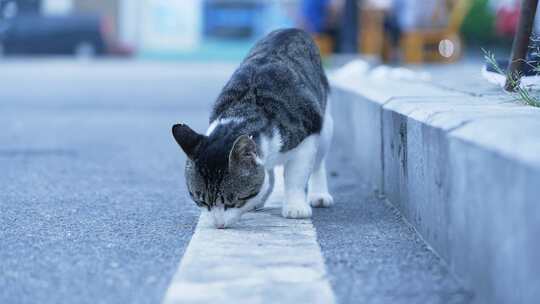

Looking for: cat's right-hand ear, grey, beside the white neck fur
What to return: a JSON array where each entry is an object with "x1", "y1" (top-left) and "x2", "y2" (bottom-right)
[{"x1": 229, "y1": 135, "x2": 257, "y2": 175}]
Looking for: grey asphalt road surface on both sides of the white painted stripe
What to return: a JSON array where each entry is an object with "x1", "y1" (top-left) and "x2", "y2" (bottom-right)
[{"x1": 0, "y1": 61, "x2": 471, "y2": 303}]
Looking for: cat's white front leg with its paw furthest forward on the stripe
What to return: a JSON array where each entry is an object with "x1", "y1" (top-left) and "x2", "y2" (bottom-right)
[{"x1": 281, "y1": 137, "x2": 317, "y2": 218}]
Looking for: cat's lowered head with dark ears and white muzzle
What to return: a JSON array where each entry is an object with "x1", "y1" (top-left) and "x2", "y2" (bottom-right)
[{"x1": 172, "y1": 124, "x2": 265, "y2": 228}]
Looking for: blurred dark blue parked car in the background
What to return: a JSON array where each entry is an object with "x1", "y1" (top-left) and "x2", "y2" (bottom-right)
[{"x1": 0, "y1": 14, "x2": 132, "y2": 57}]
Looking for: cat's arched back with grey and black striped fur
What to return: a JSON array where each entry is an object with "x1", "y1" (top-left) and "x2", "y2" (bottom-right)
[{"x1": 210, "y1": 29, "x2": 329, "y2": 149}]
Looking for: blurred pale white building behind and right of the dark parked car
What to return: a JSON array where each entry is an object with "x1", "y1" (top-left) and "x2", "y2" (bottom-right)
[{"x1": 41, "y1": 0, "x2": 203, "y2": 52}]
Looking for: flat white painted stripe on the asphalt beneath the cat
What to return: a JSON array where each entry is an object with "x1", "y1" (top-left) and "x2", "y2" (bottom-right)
[{"x1": 162, "y1": 167, "x2": 335, "y2": 304}]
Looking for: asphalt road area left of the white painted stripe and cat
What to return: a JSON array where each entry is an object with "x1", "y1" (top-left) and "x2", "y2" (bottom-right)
[{"x1": 0, "y1": 61, "x2": 235, "y2": 304}]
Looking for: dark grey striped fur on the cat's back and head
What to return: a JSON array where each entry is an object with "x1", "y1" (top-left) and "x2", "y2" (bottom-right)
[{"x1": 173, "y1": 29, "x2": 329, "y2": 217}]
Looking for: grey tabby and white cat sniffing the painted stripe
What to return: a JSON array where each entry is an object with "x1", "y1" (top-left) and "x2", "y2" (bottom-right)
[{"x1": 172, "y1": 29, "x2": 334, "y2": 228}]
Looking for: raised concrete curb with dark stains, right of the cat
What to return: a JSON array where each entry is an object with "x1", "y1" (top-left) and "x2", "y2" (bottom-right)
[{"x1": 332, "y1": 69, "x2": 540, "y2": 303}]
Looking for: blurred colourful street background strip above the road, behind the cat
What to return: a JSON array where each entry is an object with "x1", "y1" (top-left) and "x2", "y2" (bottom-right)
[{"x1": 0, "y1": 0, "x2": 538, "y2": 63}]
